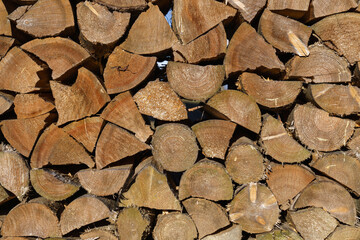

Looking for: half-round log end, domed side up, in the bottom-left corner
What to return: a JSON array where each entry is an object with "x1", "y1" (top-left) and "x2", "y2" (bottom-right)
[{"x1": 1, "y1": 203, "x2": 61, "y2": 238}]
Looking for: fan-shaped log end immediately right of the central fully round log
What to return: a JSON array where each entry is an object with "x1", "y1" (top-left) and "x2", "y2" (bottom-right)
[{"x1": 191, "y1": 119, "x2": 236, "y2": 159}]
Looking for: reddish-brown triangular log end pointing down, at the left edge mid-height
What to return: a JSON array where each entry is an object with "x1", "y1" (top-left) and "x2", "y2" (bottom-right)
[{"x1": 0, "y1": 114, "x2": 50, "y2": 157}]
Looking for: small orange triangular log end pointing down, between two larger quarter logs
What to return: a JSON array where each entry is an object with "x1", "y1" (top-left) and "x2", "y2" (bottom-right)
[{"x1": 63, "y1": 117, "x2": 104, "y2": 152}]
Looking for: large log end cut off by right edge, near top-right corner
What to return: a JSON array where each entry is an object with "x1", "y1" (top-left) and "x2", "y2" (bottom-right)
[{"x1": 312, "y1": 12, "x2": 360, "y2": 64}]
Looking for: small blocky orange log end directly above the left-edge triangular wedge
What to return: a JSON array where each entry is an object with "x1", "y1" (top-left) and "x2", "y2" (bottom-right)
[{"x1": 14, "y1": 93, "x2": 55, "y2": 118}]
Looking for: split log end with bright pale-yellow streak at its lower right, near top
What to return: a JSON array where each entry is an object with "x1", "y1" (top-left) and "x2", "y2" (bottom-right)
[{"x1": 259, "y1": 9, "x2": 312, "y2": 57}]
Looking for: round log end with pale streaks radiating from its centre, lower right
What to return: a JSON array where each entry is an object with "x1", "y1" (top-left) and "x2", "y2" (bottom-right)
[{"x1": 228, "y1": 183, "x2": 280, "y2": 233}]
